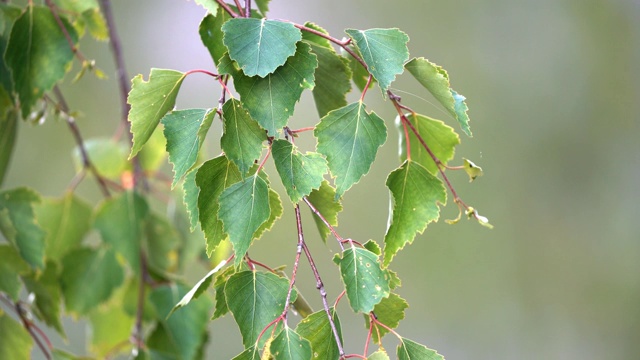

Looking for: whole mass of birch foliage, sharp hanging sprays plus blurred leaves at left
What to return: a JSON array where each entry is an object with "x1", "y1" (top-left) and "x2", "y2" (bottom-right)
[{"x1": 0, "y1": 0, "x2": 488, "y2": 359}]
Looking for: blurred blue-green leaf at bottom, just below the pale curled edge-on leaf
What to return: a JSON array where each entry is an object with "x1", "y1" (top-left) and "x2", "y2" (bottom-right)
[{"x1": 149, "y1": 284, "x2": 213, "y2": 359}]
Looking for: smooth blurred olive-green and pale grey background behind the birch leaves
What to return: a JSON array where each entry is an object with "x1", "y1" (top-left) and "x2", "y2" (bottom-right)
[{"x1": 4, "y1": 0, "x2": 640, "y2": 360}]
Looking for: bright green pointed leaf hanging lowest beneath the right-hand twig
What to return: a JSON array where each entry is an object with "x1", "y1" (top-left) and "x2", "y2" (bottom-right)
[{"x1": 383, "y1": 161, "x2": 447, "y2": 266}]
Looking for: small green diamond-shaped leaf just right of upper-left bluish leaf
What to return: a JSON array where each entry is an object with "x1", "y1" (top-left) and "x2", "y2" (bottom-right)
[{"x1": 220, "y1": 99, "x2": 267, "y2": 176}]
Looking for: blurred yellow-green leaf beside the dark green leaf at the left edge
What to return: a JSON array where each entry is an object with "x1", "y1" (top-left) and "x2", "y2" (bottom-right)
[{"x1": 35, "y1": 192, "x2": 93, "y2": 261}]
